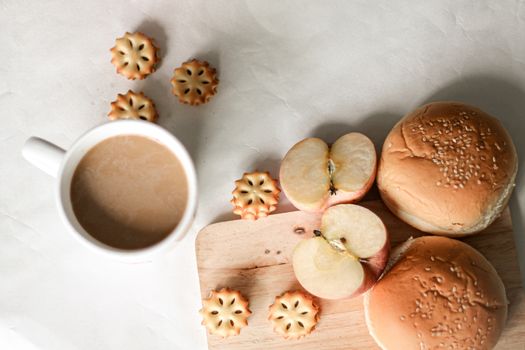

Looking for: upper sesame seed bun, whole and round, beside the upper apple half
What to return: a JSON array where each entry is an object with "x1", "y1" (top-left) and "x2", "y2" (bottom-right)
[{"x1": 377, "y1": 102, "x2": 518, "y2": 236}]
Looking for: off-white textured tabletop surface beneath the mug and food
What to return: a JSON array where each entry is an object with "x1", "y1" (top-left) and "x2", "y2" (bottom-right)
[{"x1": 0, "y1": 0, "x2": 525, "y2": 350}]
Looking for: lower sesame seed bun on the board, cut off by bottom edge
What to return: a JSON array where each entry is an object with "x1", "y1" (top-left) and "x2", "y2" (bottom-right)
[{"x1": 363, "y1": 236, "x2": 508, "y2": 350}]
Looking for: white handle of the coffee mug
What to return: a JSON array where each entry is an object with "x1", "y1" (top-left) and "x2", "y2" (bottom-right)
[{"x1": 22, "y1": 137, "x2": 66, "y2": 177}]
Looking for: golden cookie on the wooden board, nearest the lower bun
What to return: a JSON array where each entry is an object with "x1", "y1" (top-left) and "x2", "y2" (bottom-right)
[{"x1": 268, "y1": 292, "x2": 319, "y2": 339}]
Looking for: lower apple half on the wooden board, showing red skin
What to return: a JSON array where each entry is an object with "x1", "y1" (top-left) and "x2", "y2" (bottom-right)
[{"x1": 292, "y1": 204, "x2": 390, "y2": 299}]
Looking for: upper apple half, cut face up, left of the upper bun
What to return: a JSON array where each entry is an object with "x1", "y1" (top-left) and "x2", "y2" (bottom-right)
[{"x1": 279, "y1": 132, "x2": 377, "y2": 212}]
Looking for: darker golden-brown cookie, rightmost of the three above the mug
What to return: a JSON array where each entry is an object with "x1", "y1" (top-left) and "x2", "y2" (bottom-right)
[{"x1": 171, "y1": 59, "x2": 219, "y2": 106}]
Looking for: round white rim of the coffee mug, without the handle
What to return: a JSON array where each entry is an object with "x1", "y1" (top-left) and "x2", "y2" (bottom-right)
[{"x1": 55, "y1": 120, "x2": 197, "y2": 262}]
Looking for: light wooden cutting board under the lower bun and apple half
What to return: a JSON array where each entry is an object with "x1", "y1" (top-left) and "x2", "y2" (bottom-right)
[{"x1": 196, "y1": 200, "x2": 525, "y2": 350}]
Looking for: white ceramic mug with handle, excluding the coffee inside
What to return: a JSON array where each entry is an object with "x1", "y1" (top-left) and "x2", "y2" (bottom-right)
[{"x1": 22, "y1": 120, "x2": 197, "y2": 262}]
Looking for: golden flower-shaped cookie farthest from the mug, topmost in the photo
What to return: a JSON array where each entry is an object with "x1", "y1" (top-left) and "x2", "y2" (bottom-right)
[{"x1": 110, "y1": 32, "x2": 159, "y2": 80}]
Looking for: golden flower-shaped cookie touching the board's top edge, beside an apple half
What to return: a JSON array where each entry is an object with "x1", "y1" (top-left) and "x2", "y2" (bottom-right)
[{"x1": 230, "y1": 171, "x2": 281, "y2": 220}]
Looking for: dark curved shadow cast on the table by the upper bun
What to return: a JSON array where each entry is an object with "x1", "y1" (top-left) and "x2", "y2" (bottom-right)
[{"x1": 421, "y1": 75, "x2": 525, "y2": 283}]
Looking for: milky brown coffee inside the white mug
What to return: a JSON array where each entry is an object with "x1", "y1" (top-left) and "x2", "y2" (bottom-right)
[{"x1": 70, "y1": 135, "x2": 188, "y2": 250}]
